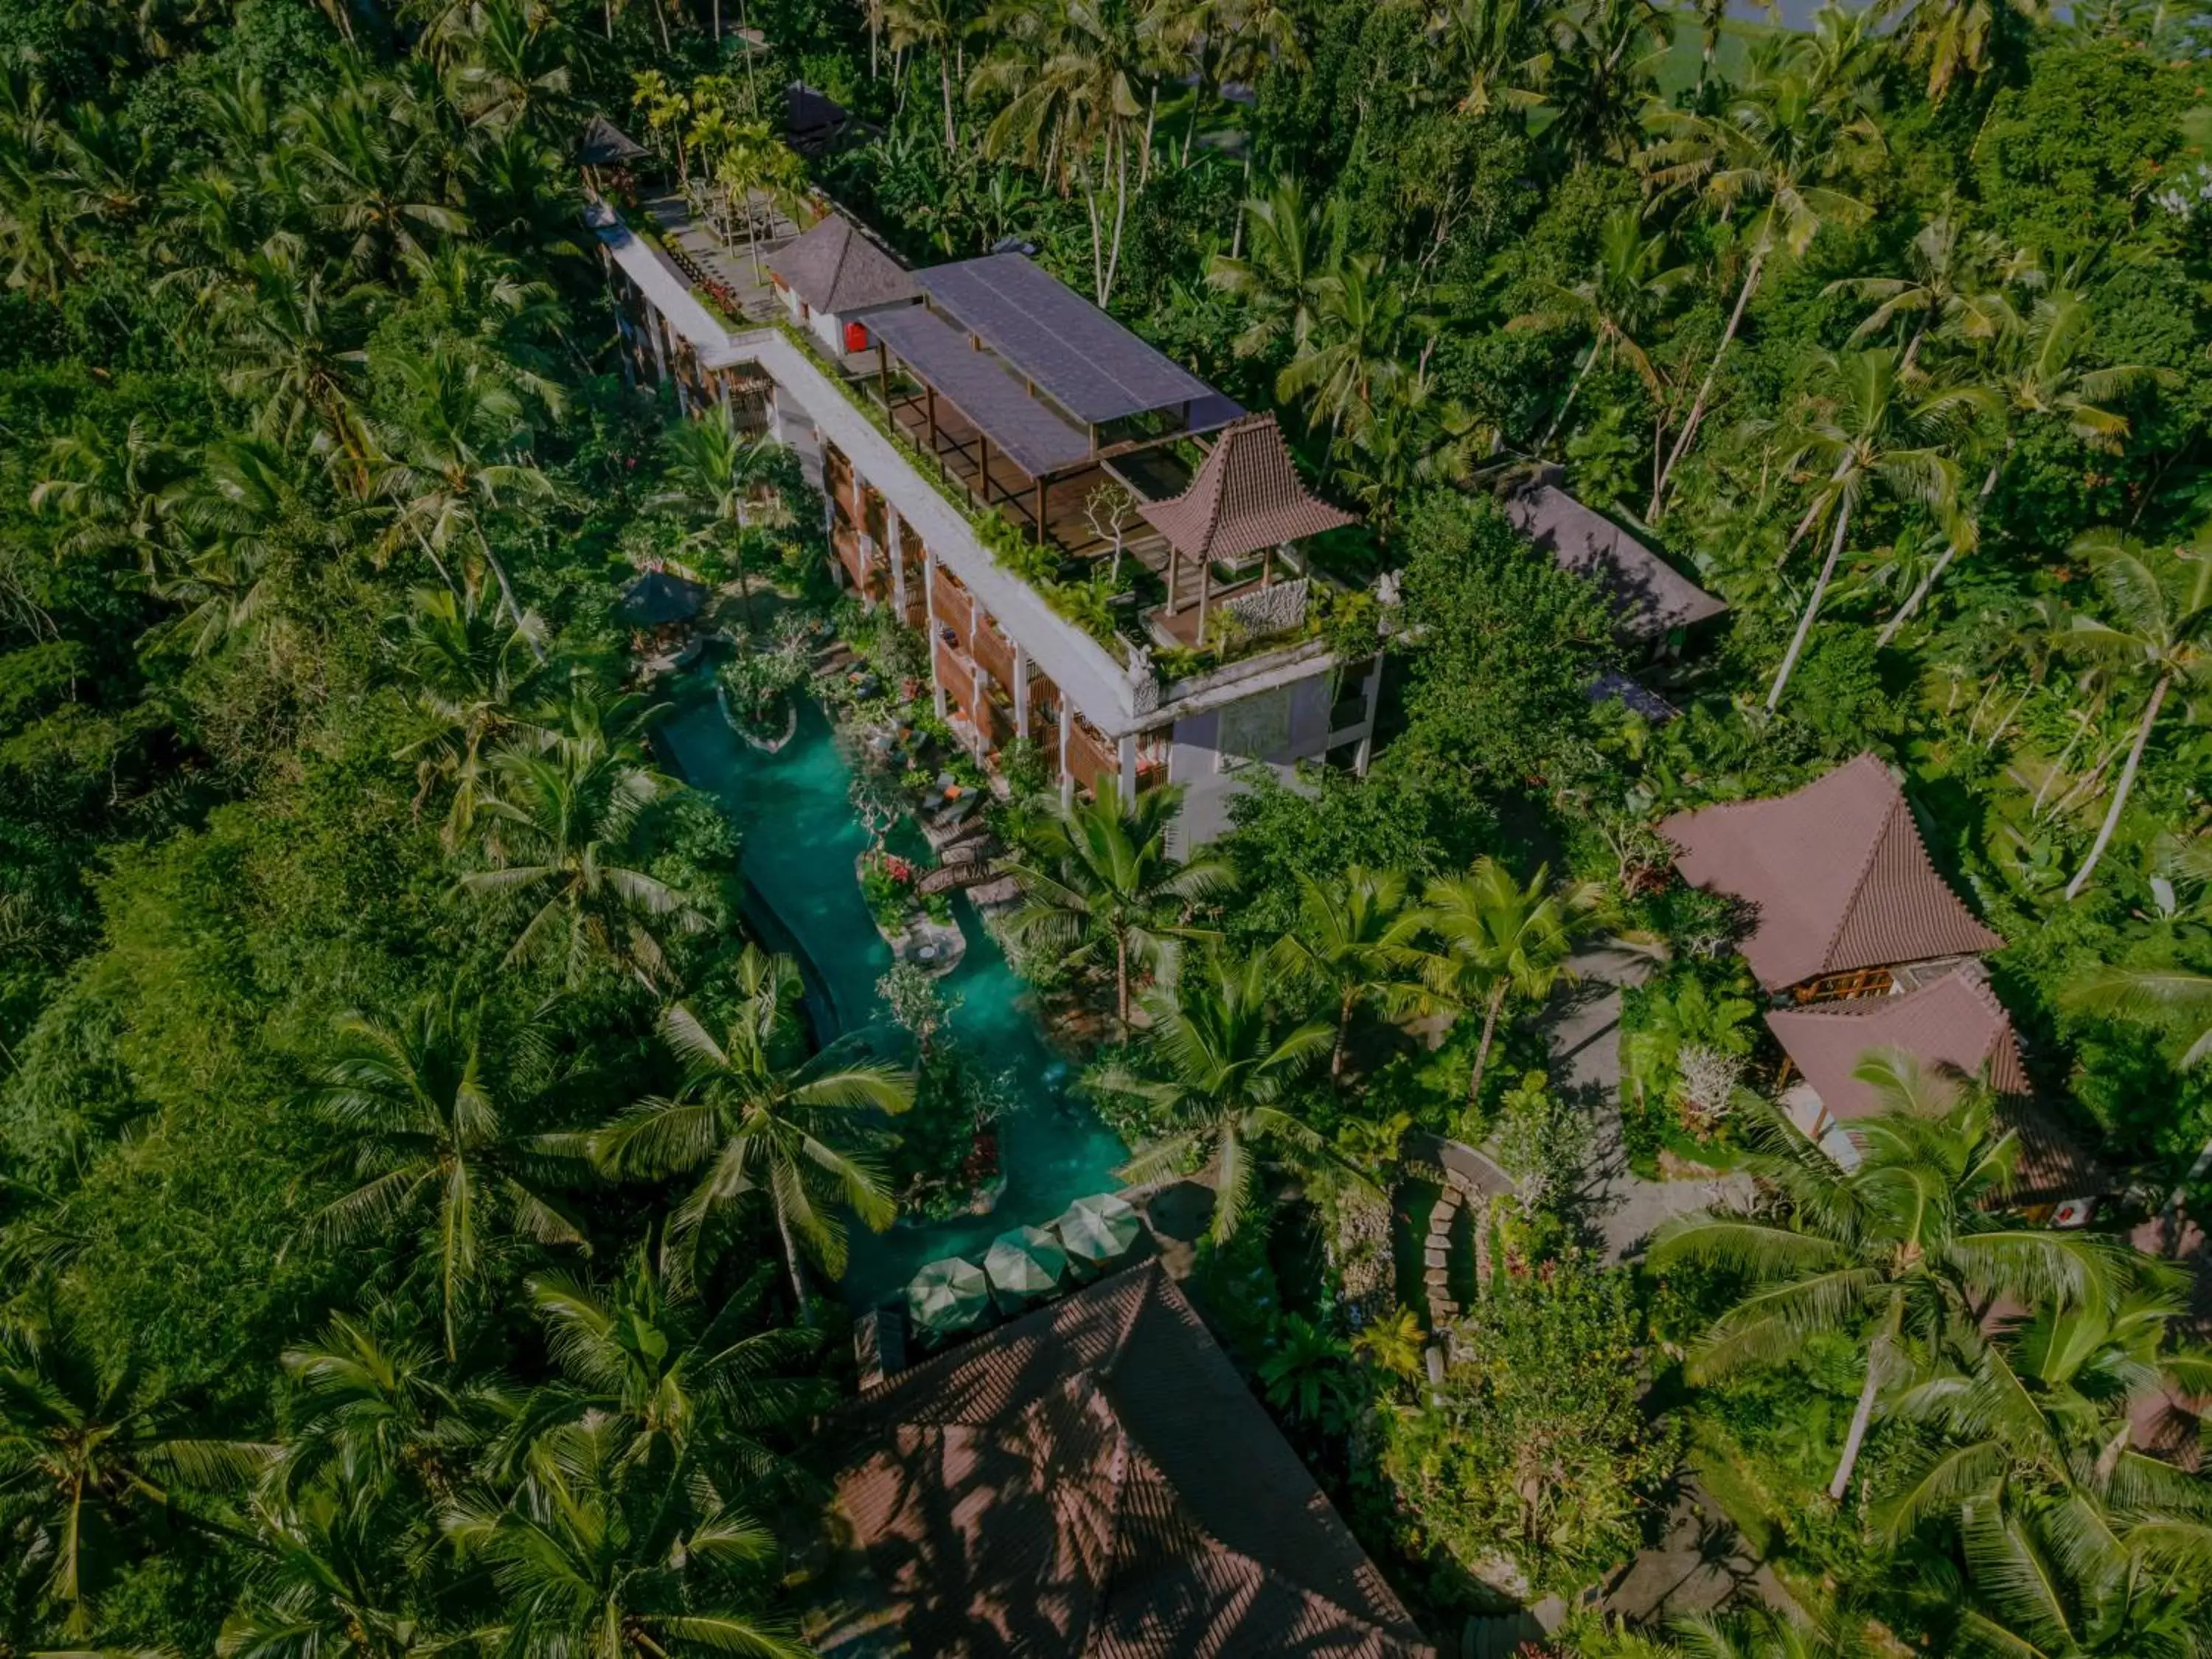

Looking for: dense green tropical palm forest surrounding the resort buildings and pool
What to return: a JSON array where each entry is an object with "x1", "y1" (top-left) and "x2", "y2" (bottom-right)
[{"x1": 0, "y1": 0, "x2": 2212, "y2": 1659}]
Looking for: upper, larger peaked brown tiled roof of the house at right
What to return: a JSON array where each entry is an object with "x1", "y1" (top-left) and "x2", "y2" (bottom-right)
[{"x1": 1659, "y1": 754, "x2": 2004, "y2": 991}]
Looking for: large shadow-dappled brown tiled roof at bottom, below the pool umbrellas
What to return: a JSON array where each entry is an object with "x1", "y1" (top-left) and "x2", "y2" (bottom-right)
[{"x1": 814, "y1": 1263, "x2": 1433, "y2": 1659}]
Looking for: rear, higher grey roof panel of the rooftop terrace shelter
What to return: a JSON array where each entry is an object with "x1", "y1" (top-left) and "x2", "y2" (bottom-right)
[{"x1": 914, "y1": 254, "x2": 1219, "y2": 425}]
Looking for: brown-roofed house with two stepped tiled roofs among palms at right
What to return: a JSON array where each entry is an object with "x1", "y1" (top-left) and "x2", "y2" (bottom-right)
[{"x1": 1659, "y1": 754, "x2": 2108, "y2": 1225}]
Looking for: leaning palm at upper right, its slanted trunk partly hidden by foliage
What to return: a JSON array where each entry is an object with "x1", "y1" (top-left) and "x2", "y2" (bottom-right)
[{"x1": 1876, "y1": 288, "x2": 2159, "y2": 646}]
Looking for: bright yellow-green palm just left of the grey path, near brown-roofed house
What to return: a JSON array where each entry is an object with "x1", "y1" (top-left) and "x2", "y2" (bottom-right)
[{"x1": 1422, "y1": 856, "x2": 1604, "y2": 1106}]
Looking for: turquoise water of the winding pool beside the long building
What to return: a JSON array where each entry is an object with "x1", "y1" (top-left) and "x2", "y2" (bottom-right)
[{"x1": 659, "y1": 697, "x2": 1128, "y2": 1307}]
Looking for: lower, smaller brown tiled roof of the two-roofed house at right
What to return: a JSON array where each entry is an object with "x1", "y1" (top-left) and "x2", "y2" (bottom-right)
[{"x1": 1767, "y1": 962, "x2": 2028, "y2": 1119}]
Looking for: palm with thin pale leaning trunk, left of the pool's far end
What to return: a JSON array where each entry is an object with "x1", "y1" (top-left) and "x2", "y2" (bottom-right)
[{"x1": 376, "y1": 347, "x2": 555, "y2": 661}]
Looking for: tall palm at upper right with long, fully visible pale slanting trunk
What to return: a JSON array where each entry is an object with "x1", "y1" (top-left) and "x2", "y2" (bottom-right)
[{"x1": 1637, "y1": 73, "x2": 1878, "y2": 520}]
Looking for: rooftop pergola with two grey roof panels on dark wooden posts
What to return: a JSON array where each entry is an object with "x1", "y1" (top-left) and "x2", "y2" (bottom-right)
[{"x1": 869, "y1": 254, "x2": 1243, "y2": 551}]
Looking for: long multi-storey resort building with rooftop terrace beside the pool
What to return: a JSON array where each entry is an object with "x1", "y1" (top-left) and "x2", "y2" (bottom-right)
[{"x1": 588, "y1": 164, "x2": 1382, "y2": 852}]
